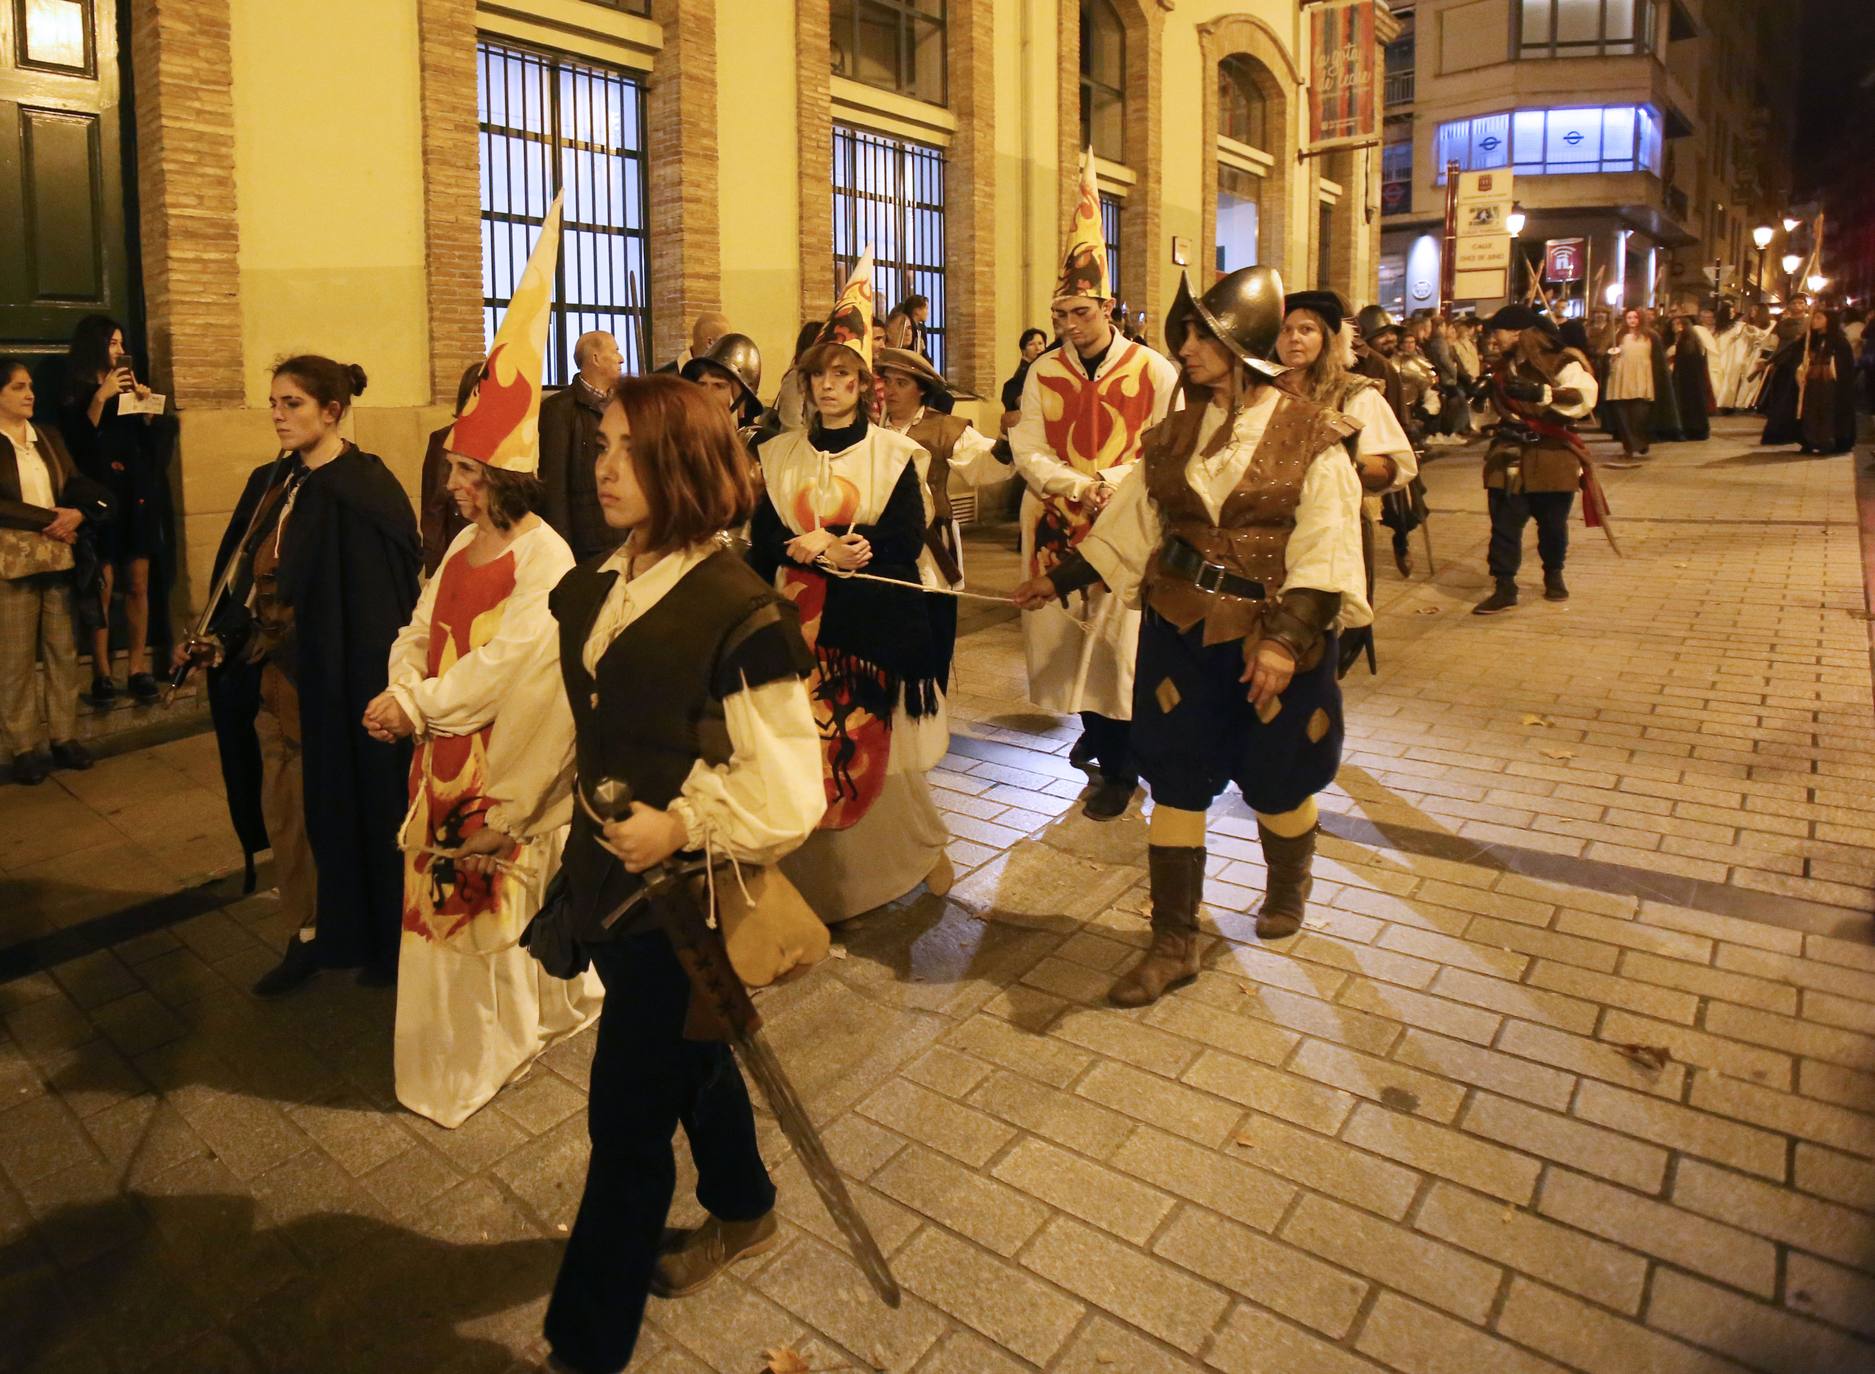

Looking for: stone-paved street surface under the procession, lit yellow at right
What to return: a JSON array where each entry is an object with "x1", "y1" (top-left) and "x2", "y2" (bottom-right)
[{"x1": 0, "y1": 424, "x2": 1875, "y2": 1374}]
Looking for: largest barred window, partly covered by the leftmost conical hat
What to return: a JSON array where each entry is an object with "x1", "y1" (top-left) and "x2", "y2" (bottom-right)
[{"x1": 476, "y1": 40, "x2": 651, "y2": 386}]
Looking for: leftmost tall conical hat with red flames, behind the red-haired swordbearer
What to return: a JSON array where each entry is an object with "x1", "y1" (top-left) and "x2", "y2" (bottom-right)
[{"x1": 444, "y1": 195, "x2": 561, "y2": 472}]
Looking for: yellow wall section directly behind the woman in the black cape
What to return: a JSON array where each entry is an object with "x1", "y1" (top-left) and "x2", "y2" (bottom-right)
[{"x1": 178, "y1": 0, "x2": 446, "y2": 605}]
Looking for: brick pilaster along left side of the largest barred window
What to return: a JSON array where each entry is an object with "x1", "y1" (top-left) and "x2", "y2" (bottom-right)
[{"x1": 416, "y1": 0, "x2": 486, "y2": 405}]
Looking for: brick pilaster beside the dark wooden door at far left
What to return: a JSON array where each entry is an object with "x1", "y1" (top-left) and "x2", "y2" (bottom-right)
[{"x1": 129, "y1": 0, "x2": 246, "y2": 409}]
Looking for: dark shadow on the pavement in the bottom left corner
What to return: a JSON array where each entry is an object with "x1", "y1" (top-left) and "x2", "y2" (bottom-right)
[{"x1": 0, "y1": 1192, "x2": 563, "y2": 1374}]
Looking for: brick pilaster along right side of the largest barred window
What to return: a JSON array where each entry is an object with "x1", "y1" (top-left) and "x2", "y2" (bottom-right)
[{"x1": 645, "y1": 0, "x2": 723, "y2": 362}]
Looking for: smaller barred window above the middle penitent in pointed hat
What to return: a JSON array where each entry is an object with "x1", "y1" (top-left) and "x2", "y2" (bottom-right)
[{"x1": 827, "y1": 124, "x2": 945, "y2": 371}]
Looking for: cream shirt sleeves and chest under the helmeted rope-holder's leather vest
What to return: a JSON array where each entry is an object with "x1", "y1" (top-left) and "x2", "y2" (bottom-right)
[{"x1": 1080, "y1": 386, "x2": 1374, "y2": 630}]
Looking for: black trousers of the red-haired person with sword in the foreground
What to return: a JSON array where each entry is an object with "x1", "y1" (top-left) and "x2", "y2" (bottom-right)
[{"x1": 546, "y1": 932, "x2": 774, "y2": 1374}]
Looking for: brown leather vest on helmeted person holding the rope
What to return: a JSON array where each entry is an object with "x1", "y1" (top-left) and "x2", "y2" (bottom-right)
[{"x1": 1142, "y1": 390, "x2": 1356, "y2": 645}]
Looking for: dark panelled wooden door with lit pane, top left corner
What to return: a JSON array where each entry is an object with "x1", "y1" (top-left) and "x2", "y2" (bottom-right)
[{"x1": 0, "y1": 0, "x2": 133, "y2": 352}]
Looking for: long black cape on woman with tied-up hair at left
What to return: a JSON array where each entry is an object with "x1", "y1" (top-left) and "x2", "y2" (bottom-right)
[{"x1": 210, "y1": 448, "x2": 422, "y2": 967}]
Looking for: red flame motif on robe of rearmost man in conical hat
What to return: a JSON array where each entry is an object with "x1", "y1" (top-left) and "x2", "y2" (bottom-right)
[{"x1": 1029, "y1": 345, "x2": 1159, "y2": 575}]
